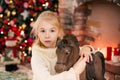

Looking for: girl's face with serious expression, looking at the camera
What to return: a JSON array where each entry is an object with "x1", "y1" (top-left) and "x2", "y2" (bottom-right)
[{"x1": 38, "y1": 22, "x2": 59, "y2": 48}]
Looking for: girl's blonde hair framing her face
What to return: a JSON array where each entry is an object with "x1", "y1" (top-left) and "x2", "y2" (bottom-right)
[{"x1": 33, "y1": 11, "x2": 64, "y2": 46}]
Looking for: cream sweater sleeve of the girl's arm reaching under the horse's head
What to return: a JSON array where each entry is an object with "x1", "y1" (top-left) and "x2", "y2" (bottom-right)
[{"x1": 31, "y1": 47, "x2": 79, "y2": 80}]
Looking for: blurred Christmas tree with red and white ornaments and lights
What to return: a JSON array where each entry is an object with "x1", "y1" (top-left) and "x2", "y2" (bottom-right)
[{"x1": 0, "y1": 0, "x2": 58, "y2": 62}]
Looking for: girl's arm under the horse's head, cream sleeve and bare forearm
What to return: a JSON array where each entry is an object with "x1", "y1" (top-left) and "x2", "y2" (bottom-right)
[{"x1": 31, "y1": 45, "x2": 87, "y2": 80}]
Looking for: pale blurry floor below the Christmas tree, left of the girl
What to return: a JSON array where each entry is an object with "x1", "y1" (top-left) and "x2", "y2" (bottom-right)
[{"x1": 0, "y1": 64, "x2": 32, "y2": 80}]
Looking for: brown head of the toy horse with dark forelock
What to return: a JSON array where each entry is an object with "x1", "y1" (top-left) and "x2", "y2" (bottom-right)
[{"x1": 55, "y1": 34, "x2": 79, "y2": 73}]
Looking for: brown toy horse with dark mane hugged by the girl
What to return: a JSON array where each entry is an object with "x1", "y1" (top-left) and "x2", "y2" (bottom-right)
[{"x1": 55, "y1": 34, "x2": 105, "y2": 80}]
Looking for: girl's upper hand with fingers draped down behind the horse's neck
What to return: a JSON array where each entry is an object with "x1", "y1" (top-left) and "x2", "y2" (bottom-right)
[{"x1": 80, "y1": 45, "x2": 94, "y2": 62}]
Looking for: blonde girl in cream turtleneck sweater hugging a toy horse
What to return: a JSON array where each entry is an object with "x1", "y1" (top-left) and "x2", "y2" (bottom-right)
[{"x1": 31, "y1": 11, "x2": 94, "y2": 80}]
